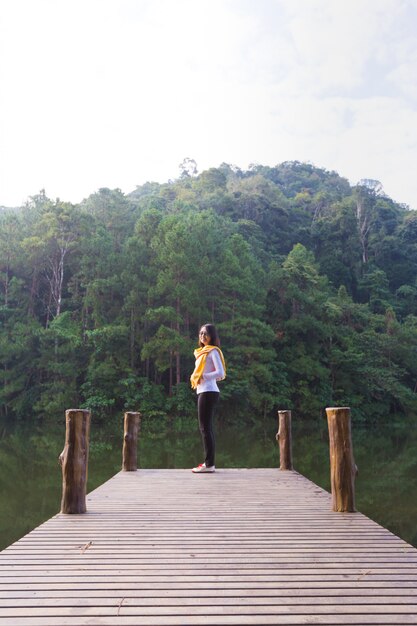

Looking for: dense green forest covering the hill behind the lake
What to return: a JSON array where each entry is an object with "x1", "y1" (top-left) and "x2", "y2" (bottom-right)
[{"x1": 0, "y1": 159, "x2": 417, "y2": 423}]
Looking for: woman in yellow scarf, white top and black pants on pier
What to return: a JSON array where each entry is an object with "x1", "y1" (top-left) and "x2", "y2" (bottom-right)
[{"x1": 190, "y1": 324, "x2": 226, "y2": 474}]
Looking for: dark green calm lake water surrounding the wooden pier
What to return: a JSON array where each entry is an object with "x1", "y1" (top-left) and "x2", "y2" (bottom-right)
[{"x1": 0, "y1": 416, "x2": 417, "y2": 549}]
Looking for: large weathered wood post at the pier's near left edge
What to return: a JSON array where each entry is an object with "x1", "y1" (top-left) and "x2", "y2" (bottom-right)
[{"x1": 59, "y1": 409, "x2": 91, "y2": 513}]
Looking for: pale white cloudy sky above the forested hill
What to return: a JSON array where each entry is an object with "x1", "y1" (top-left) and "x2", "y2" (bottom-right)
[{"x1": 0, "y1": 0, "x2": 417, "y2": 209}]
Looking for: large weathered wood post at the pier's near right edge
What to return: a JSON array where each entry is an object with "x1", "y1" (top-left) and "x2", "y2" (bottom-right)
[{"x1": 326, "y1": 407, "x2": 358, "y2": 513}]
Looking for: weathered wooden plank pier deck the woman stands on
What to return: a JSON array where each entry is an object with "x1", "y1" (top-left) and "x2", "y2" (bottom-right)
[{"x1": 0, "y1": 469, "x2": 417, "y2": 626}]
